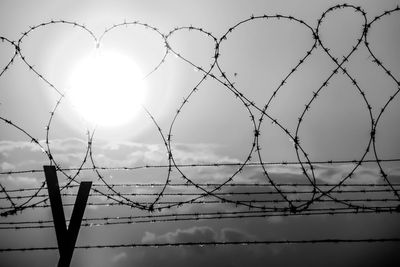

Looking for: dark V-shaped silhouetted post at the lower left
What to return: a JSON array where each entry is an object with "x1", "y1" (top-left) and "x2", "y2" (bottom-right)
[{"x1": 43, "y1": 166, "x2": 92, "y2": 267}]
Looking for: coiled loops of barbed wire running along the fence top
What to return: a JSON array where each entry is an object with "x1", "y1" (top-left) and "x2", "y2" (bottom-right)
[{"x1": 0, "y1": 4, "x2": 400, "y2": 251}]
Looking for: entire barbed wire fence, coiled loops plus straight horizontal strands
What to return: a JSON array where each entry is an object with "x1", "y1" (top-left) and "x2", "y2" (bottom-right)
[{"x1": 0, "y1": 4, "x2": 400, "y2": 264}]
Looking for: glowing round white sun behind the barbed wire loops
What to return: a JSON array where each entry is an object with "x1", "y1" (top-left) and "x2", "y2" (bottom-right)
[{"x1": 67, "y1": 48, "x2": 146, "y2": 127}]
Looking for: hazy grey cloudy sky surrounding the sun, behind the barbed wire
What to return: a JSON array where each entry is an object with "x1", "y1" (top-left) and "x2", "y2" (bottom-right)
[{"x1": 0, "y1": 0, "x2": 400, "y2": 267}]
